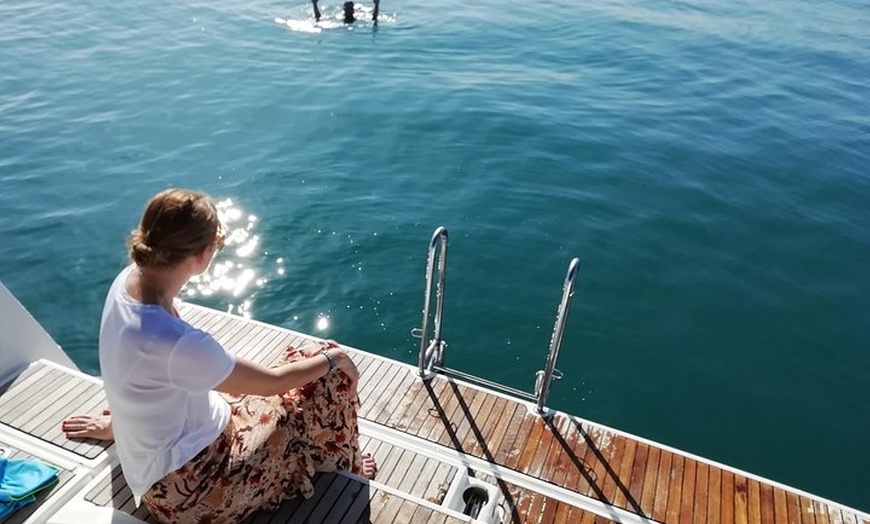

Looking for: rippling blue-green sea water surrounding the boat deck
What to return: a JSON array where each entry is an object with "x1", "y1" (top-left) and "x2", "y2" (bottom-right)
[{"x1": 0, "y1": 0, "x2": 870, "y2": 510}]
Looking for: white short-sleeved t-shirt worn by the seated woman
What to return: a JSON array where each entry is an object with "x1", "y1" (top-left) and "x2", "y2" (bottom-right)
[{"x1": 100, "y1": 265, "x2": 236, "y2": 505}]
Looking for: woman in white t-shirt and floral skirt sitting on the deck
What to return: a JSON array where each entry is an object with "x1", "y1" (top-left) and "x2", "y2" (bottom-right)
[{"x1": 63, "y1": 189, "x2": 377, "y2": 523}]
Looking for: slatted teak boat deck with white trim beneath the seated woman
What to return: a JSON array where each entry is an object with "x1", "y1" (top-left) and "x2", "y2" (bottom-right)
[{"x1": 0, "y1": 304, "x2": 870, "y2": 524}]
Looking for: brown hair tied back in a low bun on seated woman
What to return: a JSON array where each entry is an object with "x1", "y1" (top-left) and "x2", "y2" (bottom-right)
[{"x1": 127, "y1": 189, "x2": 220, "y2": 267}]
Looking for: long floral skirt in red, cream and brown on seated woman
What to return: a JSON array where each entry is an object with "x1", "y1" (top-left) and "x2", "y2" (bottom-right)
[{"x1": 142, "y1": 342, "x2": 362, "y2": 524}]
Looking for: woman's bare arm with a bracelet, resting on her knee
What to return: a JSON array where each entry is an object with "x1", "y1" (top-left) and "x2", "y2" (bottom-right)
[{"x1": 215, "y1": 348, "x2": 359, "y2": 396}]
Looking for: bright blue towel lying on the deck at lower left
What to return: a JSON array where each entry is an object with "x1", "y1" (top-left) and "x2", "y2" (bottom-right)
[{"x1": 0, "y1": 457, "x2": 57, "y2": 519}]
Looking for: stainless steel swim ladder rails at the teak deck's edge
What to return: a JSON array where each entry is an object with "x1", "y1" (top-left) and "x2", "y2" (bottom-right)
[{"x1": 411, "y1": 227, "x2": 580, "y2": 418}]
